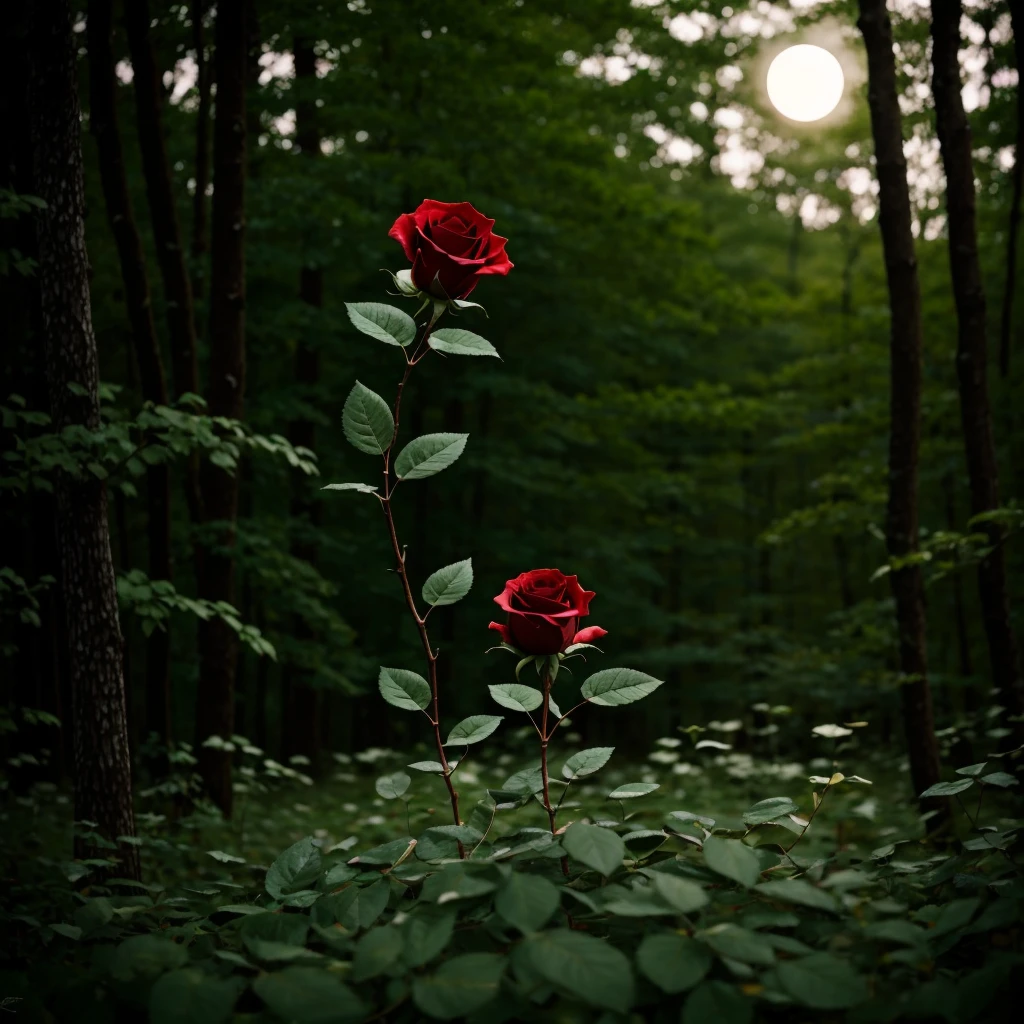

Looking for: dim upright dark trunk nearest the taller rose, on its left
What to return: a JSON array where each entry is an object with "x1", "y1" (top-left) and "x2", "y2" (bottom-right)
[{"x1": 283, "y1": 38, "x2": 324, "y2": 770}]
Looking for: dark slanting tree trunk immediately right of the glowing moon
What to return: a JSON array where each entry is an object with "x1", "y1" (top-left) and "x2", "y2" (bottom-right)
[{"x1": 857, "y1": 0, "x2": 948, "y2": 828}]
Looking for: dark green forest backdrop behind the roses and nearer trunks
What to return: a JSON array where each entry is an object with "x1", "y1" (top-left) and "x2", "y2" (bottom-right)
[{"x1": 0, "y1": 0, "x2": 1024, "y2": 807}]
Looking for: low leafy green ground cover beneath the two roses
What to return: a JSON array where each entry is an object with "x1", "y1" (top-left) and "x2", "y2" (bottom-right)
[{"x1": 0, "y1": 723, "x2": 1024, "y2": 1024}]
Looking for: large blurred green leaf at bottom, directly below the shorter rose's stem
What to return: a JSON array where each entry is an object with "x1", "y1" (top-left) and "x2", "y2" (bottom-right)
[{"x1": 516, "y1": 928, "x2": 633, "y2": 1014}]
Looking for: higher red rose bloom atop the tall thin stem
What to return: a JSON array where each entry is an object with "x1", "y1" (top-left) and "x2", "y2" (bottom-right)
[{"x1": 388, "y1": 199, "x2": 512, "y2": 299}]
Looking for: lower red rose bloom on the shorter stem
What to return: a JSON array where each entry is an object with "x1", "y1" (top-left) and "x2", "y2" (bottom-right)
[{"x1": 487, "y1": 569, "x2": 608, "y2": 654}]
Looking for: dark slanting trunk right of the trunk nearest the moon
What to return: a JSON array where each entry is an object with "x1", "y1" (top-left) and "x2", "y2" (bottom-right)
[{"x1": 932, "y1": 0, "x2": 1024, "y2": 736}]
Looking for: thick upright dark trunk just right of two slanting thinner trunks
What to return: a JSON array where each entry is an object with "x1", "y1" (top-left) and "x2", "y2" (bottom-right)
[{"x1": 196, "y1": 0, "x2": 247, "y2": 814}]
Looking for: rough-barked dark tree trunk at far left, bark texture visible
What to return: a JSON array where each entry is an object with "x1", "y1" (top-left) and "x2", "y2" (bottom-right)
[{"x1": 31, "y1": 0, "x2": 139, "y2": 879}]
